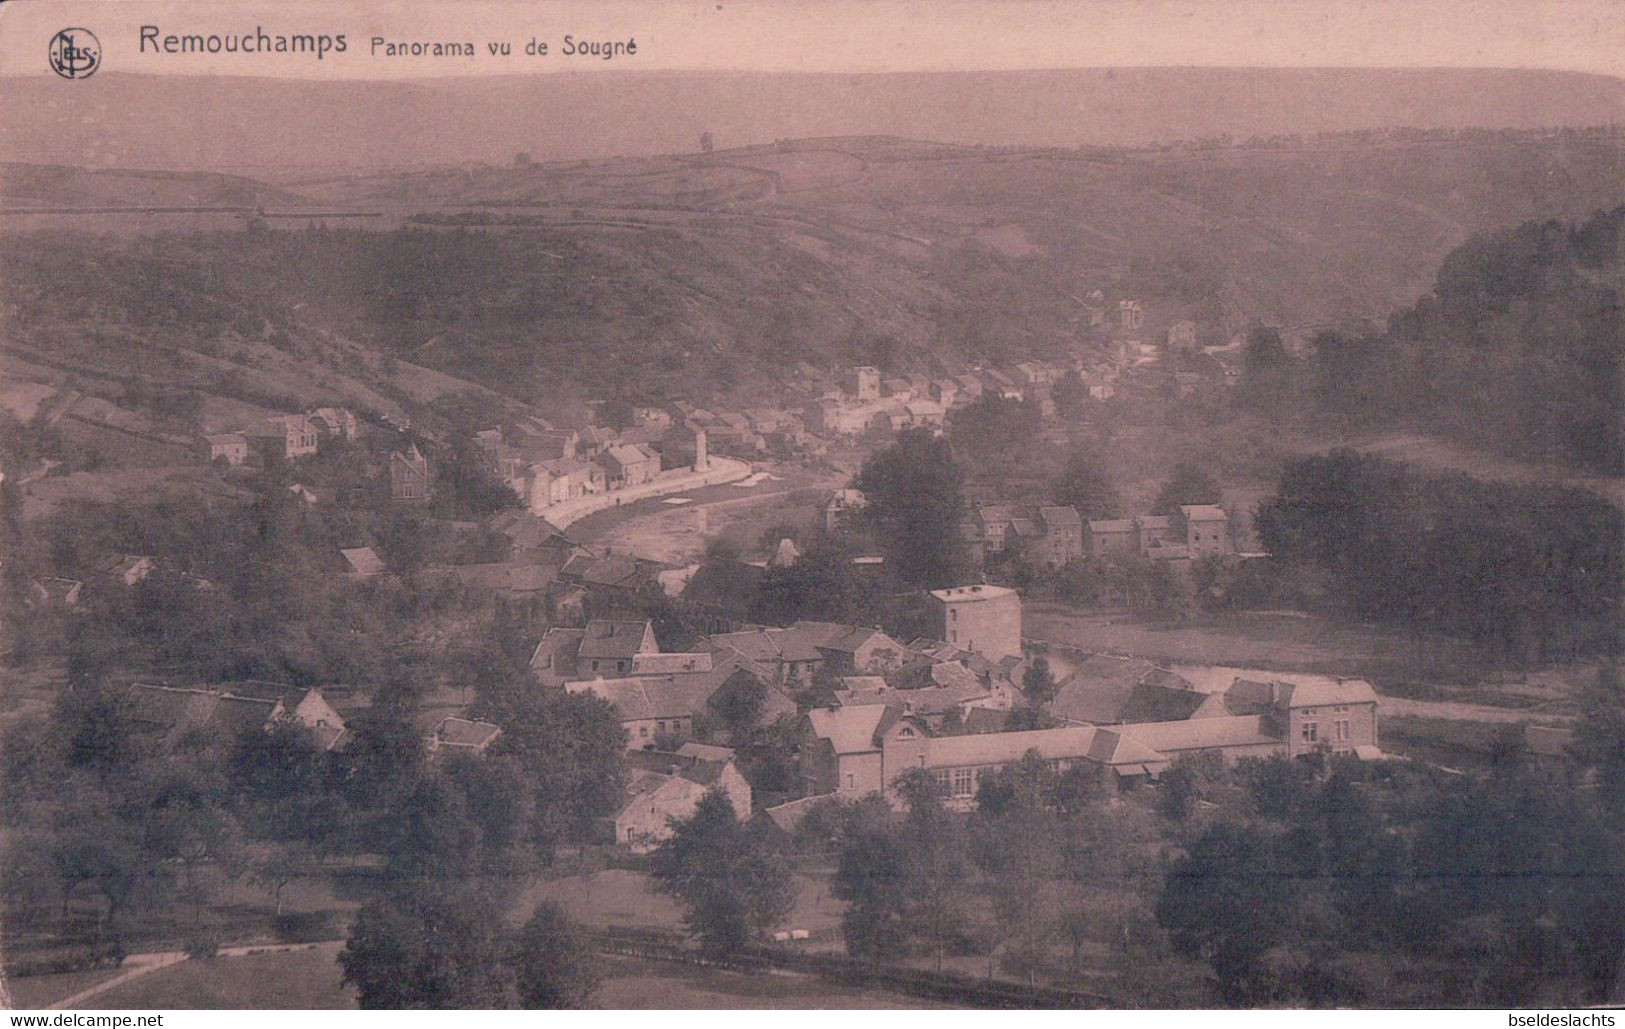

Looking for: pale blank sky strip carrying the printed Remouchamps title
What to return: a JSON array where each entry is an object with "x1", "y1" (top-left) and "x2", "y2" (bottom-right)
[{"x1": 0, "y1": 0, "x2": 1625, "y2": 80}]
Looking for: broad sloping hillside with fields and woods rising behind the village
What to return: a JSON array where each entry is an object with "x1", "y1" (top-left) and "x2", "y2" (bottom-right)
[{"x1": 5, "y1": 132, "x2": 1625, "y2": 406}]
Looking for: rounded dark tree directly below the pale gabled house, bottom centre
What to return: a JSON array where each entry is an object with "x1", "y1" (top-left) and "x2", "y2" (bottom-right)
[{"x1": 650, "y1": 788, "x2": 795, "y2": 954}]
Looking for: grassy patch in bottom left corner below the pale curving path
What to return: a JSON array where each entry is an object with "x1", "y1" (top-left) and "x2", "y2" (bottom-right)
[{"x1": 81, "y1": 943, "x2": 356, "y2": 1009}]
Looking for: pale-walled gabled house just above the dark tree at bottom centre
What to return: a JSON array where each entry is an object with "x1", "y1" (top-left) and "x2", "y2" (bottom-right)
[{"x1": 614, "y1": 743, "x2": 751, "y2": 853}]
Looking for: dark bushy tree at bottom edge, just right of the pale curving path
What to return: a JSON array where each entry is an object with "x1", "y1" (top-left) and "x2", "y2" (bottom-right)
[{"x1": 338, "y1": 883, "x2": 514, "y2": 1011}]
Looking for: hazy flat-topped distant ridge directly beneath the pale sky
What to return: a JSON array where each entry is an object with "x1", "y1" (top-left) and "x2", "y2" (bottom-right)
[{"x1": 0, "y1": 68, "x2": 1625, "y2": 177}]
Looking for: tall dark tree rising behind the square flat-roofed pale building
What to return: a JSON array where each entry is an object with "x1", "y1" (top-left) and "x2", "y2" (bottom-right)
[{"x1": 853, "y1": 429, "x2": 964, "y2": 588}]
